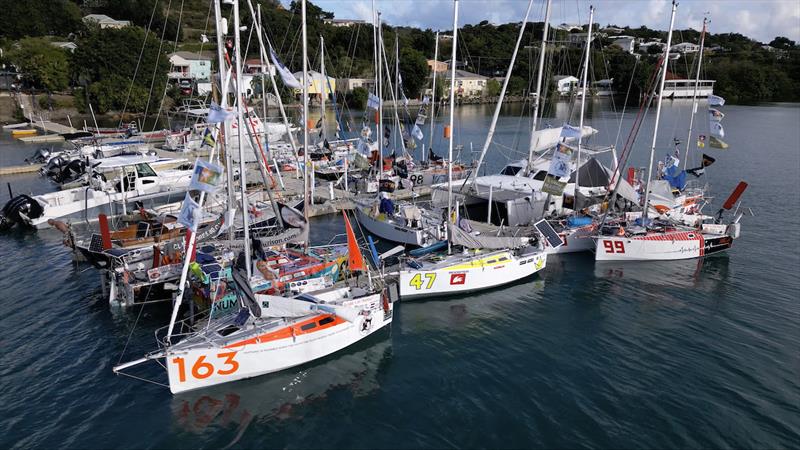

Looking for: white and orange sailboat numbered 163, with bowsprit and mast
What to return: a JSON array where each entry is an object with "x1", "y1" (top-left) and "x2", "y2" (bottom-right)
[{"x1": 114, "y1": 0, "x2": 393, "y2": 393}]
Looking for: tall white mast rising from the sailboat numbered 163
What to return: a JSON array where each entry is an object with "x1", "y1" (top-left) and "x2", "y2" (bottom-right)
[{"x1": 233, "y1": 0, "x2": 253, "y2": 280}]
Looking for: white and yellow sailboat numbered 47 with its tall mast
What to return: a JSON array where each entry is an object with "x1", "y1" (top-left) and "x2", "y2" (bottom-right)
[{"x1": 399, "y1": 0, "x2": 547, "y2": 299}]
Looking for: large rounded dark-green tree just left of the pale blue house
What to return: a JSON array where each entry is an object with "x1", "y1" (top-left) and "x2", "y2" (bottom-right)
[{"x1": 72, "y1": 26, "x2": 170, "y2": 112}]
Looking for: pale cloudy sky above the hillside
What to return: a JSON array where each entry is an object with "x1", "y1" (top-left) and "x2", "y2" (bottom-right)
[{"x1": 292, "y1": 0, "x2": 800, "y2": 43}]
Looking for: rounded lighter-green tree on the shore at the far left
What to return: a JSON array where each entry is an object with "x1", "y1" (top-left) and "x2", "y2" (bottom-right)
[{"x1": 9, "y1": 38, "x2": 69, "y2": 91}]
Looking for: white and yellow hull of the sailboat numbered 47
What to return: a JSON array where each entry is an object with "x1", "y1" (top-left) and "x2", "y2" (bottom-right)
[{"x1": 400, "y1": 250, "x2": 547, "y2": 300}]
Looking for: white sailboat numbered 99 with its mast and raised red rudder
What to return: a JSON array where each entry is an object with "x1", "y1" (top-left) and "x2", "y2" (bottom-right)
[{"x1": 595, "y1": 2, "x2": 747, "y2": 261}]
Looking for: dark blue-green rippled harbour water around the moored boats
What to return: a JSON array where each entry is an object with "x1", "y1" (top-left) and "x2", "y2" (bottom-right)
[{"x1": 0, "y1": 102, "x2": 800, "y2": 448}]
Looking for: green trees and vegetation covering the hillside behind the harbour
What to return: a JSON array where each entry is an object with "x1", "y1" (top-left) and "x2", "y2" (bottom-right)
[{"x1": 0, "y1": 0, "x2": 800, "y2": 112}]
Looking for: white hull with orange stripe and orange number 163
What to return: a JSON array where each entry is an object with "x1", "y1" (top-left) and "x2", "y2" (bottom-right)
[{"x1": 165, "y1": 294, "x2": 393, "y2": 394}]
